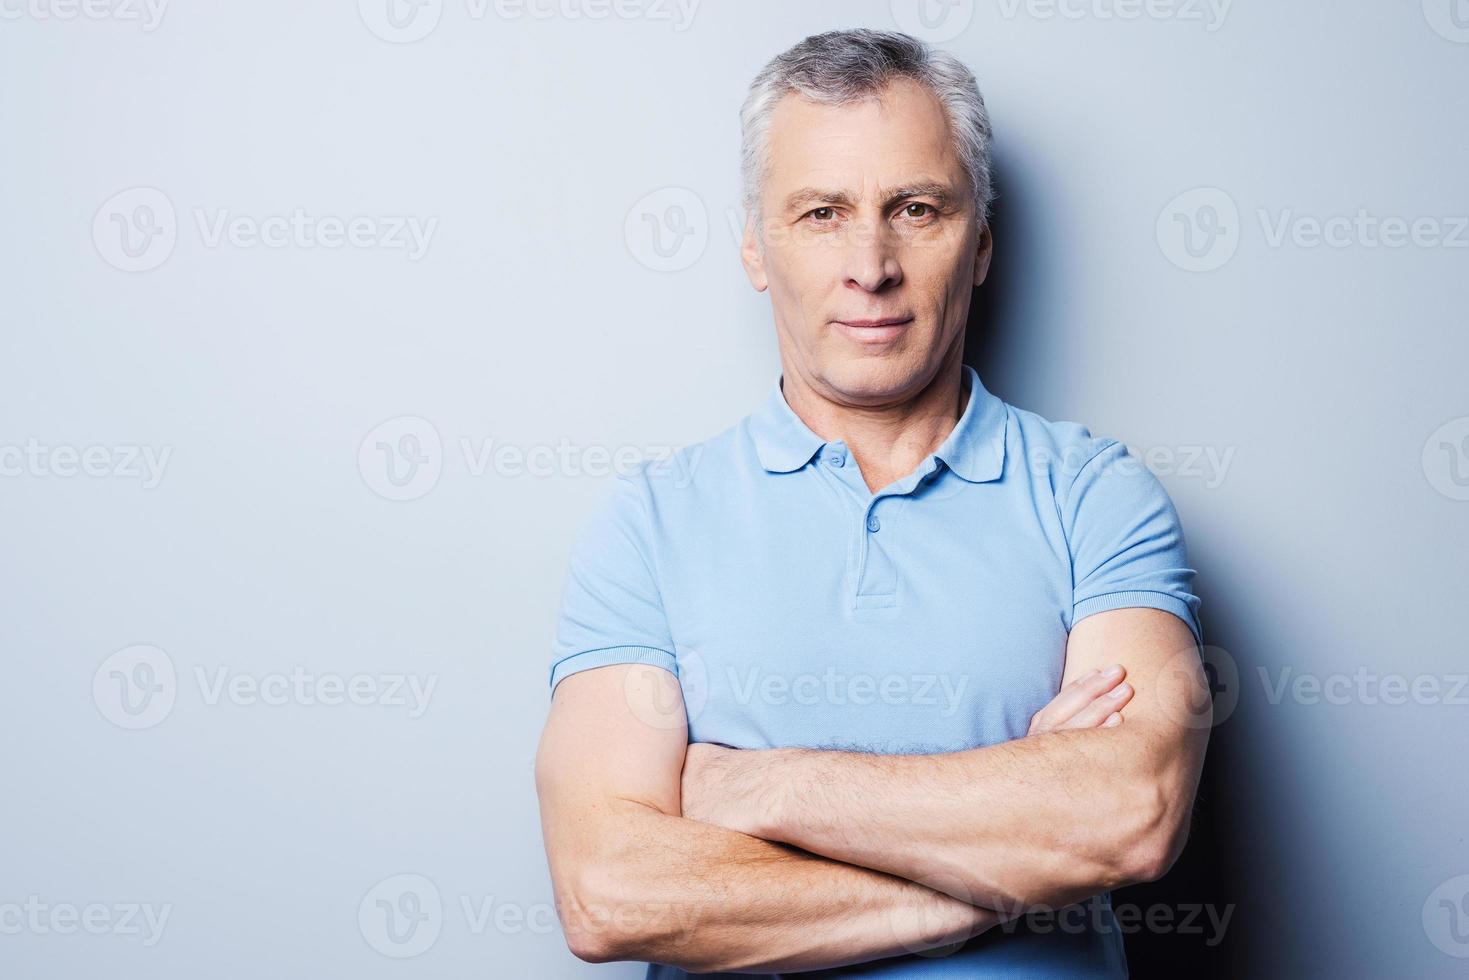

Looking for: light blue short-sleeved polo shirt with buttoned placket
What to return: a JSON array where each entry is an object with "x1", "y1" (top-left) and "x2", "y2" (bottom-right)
[{"x1": 551, "y1": 366, "x2": 1200, "y2": 980}]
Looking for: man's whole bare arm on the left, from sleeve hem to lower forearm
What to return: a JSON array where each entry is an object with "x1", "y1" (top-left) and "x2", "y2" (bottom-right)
[{"x1": 536, "y1": 664, "x2": 996, "y2": 973}]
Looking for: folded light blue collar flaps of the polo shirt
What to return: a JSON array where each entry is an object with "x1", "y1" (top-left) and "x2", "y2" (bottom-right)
[{"x1": 749, "y1": 364, "x2": 1009, "y2": 483}]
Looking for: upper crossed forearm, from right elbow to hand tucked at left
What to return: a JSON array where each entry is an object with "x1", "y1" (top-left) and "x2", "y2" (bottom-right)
[{"x1": 755, "y1": 724, "x2": 1202, "y2": 914}]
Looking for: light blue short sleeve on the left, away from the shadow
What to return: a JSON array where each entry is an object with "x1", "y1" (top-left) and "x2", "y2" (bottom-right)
[{"x1": 551, "y1": 473, "x2": 677, "y2": 693}]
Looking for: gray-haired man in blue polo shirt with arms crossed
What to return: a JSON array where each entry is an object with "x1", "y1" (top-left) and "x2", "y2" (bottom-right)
[{"x1": 536, "y1": 31, "x2": 1209, "y2": 979}]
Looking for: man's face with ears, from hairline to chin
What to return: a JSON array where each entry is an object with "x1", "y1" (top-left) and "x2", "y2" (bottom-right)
[{"x1": 742, "y1": 79, "x2": 990, "y2": 407}]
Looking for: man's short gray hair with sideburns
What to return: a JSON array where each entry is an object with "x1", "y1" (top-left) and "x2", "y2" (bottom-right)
[{"x1": 739, "y1": 28, "x2": 995, "y2": 226}]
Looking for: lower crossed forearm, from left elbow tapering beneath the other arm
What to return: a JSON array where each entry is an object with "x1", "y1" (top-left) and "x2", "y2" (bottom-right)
[{"x1": 548, "y1": 801, "x2": 997, "y2": 973}]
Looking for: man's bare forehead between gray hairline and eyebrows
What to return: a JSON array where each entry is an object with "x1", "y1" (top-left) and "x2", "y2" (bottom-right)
[{"x1": 767, "y1": 78, "x2": 964, "y2": 194}]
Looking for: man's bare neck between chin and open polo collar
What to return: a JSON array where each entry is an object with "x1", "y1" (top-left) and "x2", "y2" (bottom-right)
[{"x1": 782, "y1": 347, "x2": 970, "y2": 492}]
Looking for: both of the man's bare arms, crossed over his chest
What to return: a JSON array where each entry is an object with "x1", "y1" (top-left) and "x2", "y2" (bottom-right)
[{"x1": 536, "y1": 610, "x2": 1208, "y2": 973}]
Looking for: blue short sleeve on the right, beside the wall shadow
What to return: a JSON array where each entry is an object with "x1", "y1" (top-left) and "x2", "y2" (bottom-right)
[{"x1": 1062, "y1": 442, "x2": 1203, "y2": 644}]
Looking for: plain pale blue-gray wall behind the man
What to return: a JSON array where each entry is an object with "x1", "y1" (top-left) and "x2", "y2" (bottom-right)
[{"x1": 0, "y1": 0, "x2": 1469, "y2": 979}]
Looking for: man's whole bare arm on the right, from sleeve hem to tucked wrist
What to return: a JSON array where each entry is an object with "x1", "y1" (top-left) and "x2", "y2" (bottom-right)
[{"x1": 682, "y1": 608, "x2": 1210, "y2": 915}]
